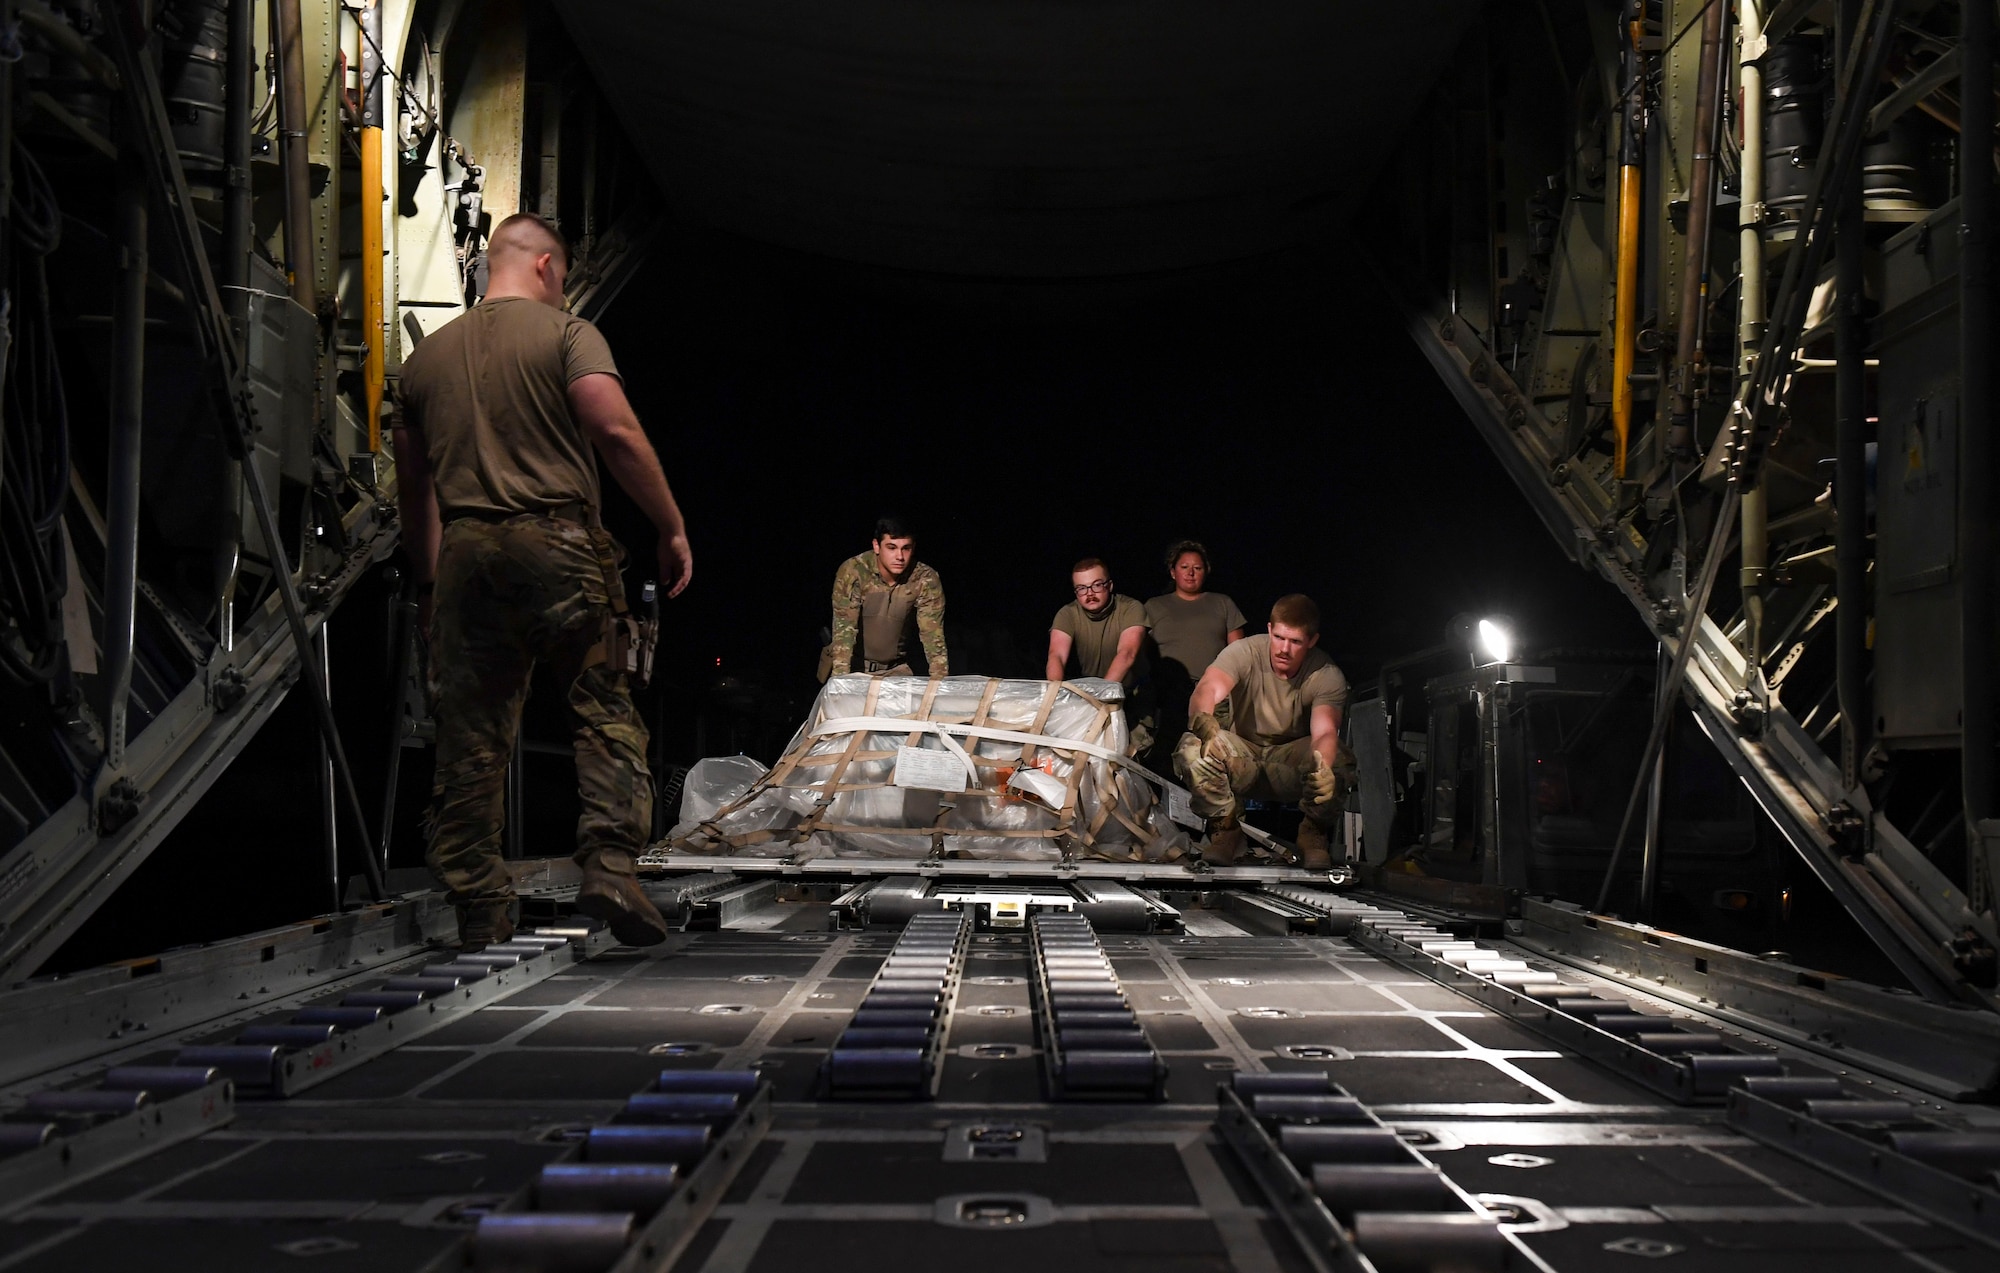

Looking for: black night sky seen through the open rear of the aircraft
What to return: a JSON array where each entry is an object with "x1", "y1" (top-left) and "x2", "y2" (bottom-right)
[{"x1": 604, "y1": 236, "x2": 1646, "y2": 744}]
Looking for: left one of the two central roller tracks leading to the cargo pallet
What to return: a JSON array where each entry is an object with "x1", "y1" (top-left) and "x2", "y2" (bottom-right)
[{"x1": 820, "y1": 911, "x2": 974, "y2": 1099}]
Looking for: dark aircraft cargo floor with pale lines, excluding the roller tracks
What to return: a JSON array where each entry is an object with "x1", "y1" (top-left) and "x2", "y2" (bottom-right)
[{"x1": 0, "y1": 911, "x2": 1992, "y2": 1273}]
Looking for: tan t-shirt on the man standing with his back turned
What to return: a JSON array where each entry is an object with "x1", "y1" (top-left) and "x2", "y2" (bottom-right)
[{"x1": 402, "y1": 296, "x2": 618, "y2": 520}]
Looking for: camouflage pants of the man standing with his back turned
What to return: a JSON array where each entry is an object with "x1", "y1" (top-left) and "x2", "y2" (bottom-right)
[{"x1": 426, "y1": 516, "x2": 652, "y2": 907}]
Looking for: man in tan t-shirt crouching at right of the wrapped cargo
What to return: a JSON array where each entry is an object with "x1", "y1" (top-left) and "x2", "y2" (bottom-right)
[{"x1": 1174, "y1": 592, "x2": 1354, "y2": 871}]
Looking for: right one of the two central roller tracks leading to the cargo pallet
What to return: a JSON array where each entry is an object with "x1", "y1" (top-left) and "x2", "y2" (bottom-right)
[{"x1": 1028, "y1": 915, "x2": 1166, "y2": 1101}]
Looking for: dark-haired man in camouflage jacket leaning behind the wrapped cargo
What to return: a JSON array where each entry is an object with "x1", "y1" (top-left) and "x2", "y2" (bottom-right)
[{"x1": 820, "y1": 516, "x2": 950, "y2": 681}]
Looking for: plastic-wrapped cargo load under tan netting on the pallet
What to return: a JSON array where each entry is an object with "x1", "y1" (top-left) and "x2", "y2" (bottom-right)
[{"x1": 666, "y1": 675, "x2": 1186, "y2": 861}]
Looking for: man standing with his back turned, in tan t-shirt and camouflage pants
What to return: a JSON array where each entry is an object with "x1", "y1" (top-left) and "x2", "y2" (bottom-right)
[{"x1": 396, "y1": 212, "x2": 694, "y2": 951}]
